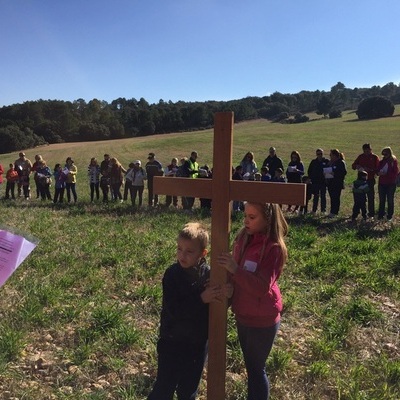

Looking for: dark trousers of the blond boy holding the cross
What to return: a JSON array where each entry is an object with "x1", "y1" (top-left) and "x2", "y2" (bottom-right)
[{"x1": 147, "y1": 339, "x2": 207, "y2": 400}]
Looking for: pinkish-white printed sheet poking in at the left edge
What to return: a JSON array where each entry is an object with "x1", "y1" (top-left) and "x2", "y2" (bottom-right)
[{"x1": 0, "y1": 229, "x2": 36, "y2": 287}]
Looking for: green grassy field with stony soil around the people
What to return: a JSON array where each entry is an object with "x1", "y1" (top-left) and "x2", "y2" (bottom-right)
[{"x1": 0, "y1": 107, "x2": 400, "y2": 400}]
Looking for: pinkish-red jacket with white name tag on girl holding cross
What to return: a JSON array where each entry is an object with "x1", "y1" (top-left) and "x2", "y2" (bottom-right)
[{"x1": 231, "y1": 234, "x2": 282, "y2": 327}]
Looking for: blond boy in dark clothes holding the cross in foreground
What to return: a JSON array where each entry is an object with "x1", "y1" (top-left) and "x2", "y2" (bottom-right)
[{"x1": 148, "y1": 222, "x2": 227, "y2": 400}]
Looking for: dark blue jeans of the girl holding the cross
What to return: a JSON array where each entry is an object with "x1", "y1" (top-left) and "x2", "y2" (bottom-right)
[{"x1": 236, "y1": 322, "x2": 279, "y2": 400}]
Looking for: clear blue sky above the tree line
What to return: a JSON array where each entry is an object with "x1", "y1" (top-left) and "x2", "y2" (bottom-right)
[{"x1": 0, "y1": 0, "x2": 400, "y2": 107}]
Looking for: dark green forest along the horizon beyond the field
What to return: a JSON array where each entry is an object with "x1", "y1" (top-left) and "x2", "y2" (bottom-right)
[{"x1": 0, "y1": 82, "x2": 400, "y2": 153}]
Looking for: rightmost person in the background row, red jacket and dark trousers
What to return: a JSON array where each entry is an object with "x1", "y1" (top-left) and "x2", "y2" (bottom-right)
[{"x1": 378, "y1": 147, "x2": 399, "y2": 222}]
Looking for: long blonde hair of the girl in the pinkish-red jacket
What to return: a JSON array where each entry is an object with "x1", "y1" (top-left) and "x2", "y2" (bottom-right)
[{"x1": 236, "y1": 202, "x2": 289, "y2": 272}]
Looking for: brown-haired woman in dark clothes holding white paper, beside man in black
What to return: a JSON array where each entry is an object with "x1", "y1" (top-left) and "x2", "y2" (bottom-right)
[{"x1": 325, "y1": 149, "x2": 347, "y2": 218}]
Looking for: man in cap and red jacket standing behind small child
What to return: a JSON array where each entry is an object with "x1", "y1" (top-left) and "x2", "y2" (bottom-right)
[{"x1": 351, "y1": 143, "x2": 379, "y2": 218}]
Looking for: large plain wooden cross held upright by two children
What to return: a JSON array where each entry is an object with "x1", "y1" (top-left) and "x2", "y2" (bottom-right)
[{"x1": 154, "y1": 112, "x2": 306, "y2": 400}]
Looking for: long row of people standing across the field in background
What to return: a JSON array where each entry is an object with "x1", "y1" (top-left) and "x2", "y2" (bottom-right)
[{"x1": 0, "y1": 143, "x2": 399, "y2": 220}]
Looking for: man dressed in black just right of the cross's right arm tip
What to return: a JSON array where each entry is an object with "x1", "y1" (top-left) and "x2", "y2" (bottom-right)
[{"x1": 307, "y1": 148, "x2": 329, "y2": 214}]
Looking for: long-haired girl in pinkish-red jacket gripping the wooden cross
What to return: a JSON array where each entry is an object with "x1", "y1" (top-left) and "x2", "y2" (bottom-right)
[{"x1": 218, "y1": 203, "x2": 288, "y2": 400}]
